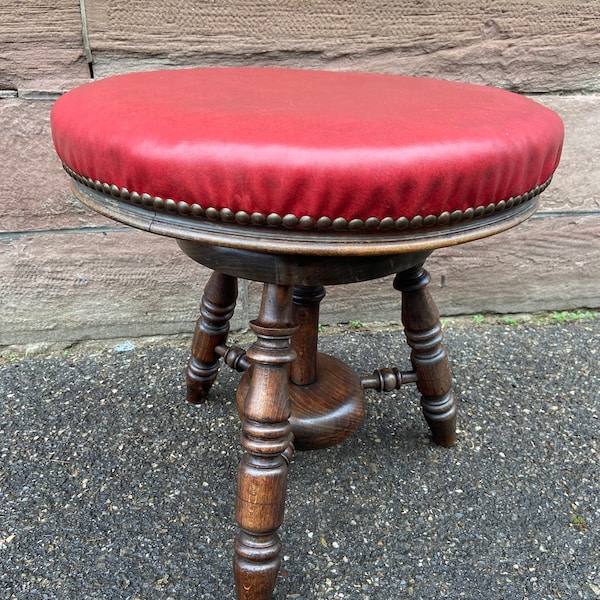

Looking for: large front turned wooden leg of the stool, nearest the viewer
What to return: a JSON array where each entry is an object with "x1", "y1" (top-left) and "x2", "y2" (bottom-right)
[{"x1": 233, "y1": 283, "x2": 297, "y2": 600}]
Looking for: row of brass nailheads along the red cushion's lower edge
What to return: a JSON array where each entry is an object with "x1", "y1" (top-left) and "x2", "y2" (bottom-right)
[{"x1": 63, "y1": 164, "x2": 552, "y2": 231}]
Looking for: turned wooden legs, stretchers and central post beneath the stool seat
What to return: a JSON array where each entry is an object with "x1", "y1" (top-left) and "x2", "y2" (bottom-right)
[{"x1": 187, "y1": 264, "x2": 456, "y2": 600}]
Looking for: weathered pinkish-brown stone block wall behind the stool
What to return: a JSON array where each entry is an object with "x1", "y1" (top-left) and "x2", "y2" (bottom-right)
[{"x1": 0, "y1": 0, "x2": 600, "y2": 346}]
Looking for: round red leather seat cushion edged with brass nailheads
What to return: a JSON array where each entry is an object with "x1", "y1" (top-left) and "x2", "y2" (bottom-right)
[{"x1": 52, "y1": 68, "x2": 563, "y2": 230}]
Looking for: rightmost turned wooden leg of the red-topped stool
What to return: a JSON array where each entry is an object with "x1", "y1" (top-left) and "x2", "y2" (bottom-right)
[{"x1": 394, "y1": 266, "x2": 456, "y2": 446}]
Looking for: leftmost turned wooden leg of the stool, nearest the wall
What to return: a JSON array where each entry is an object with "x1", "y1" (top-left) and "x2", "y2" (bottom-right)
[{"x1": 186, "y1": 271, "x2": 237, "y2": 404}]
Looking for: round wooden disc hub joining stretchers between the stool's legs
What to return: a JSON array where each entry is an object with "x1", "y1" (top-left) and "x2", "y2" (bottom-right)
[{"x1": 237, "y1": 353, "x2": 365, "y2": 450}]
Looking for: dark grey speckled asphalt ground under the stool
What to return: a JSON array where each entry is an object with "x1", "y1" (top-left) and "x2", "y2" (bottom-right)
[{"x1": 0, "y1": 319, "x2": 600, "y2": 600}]
